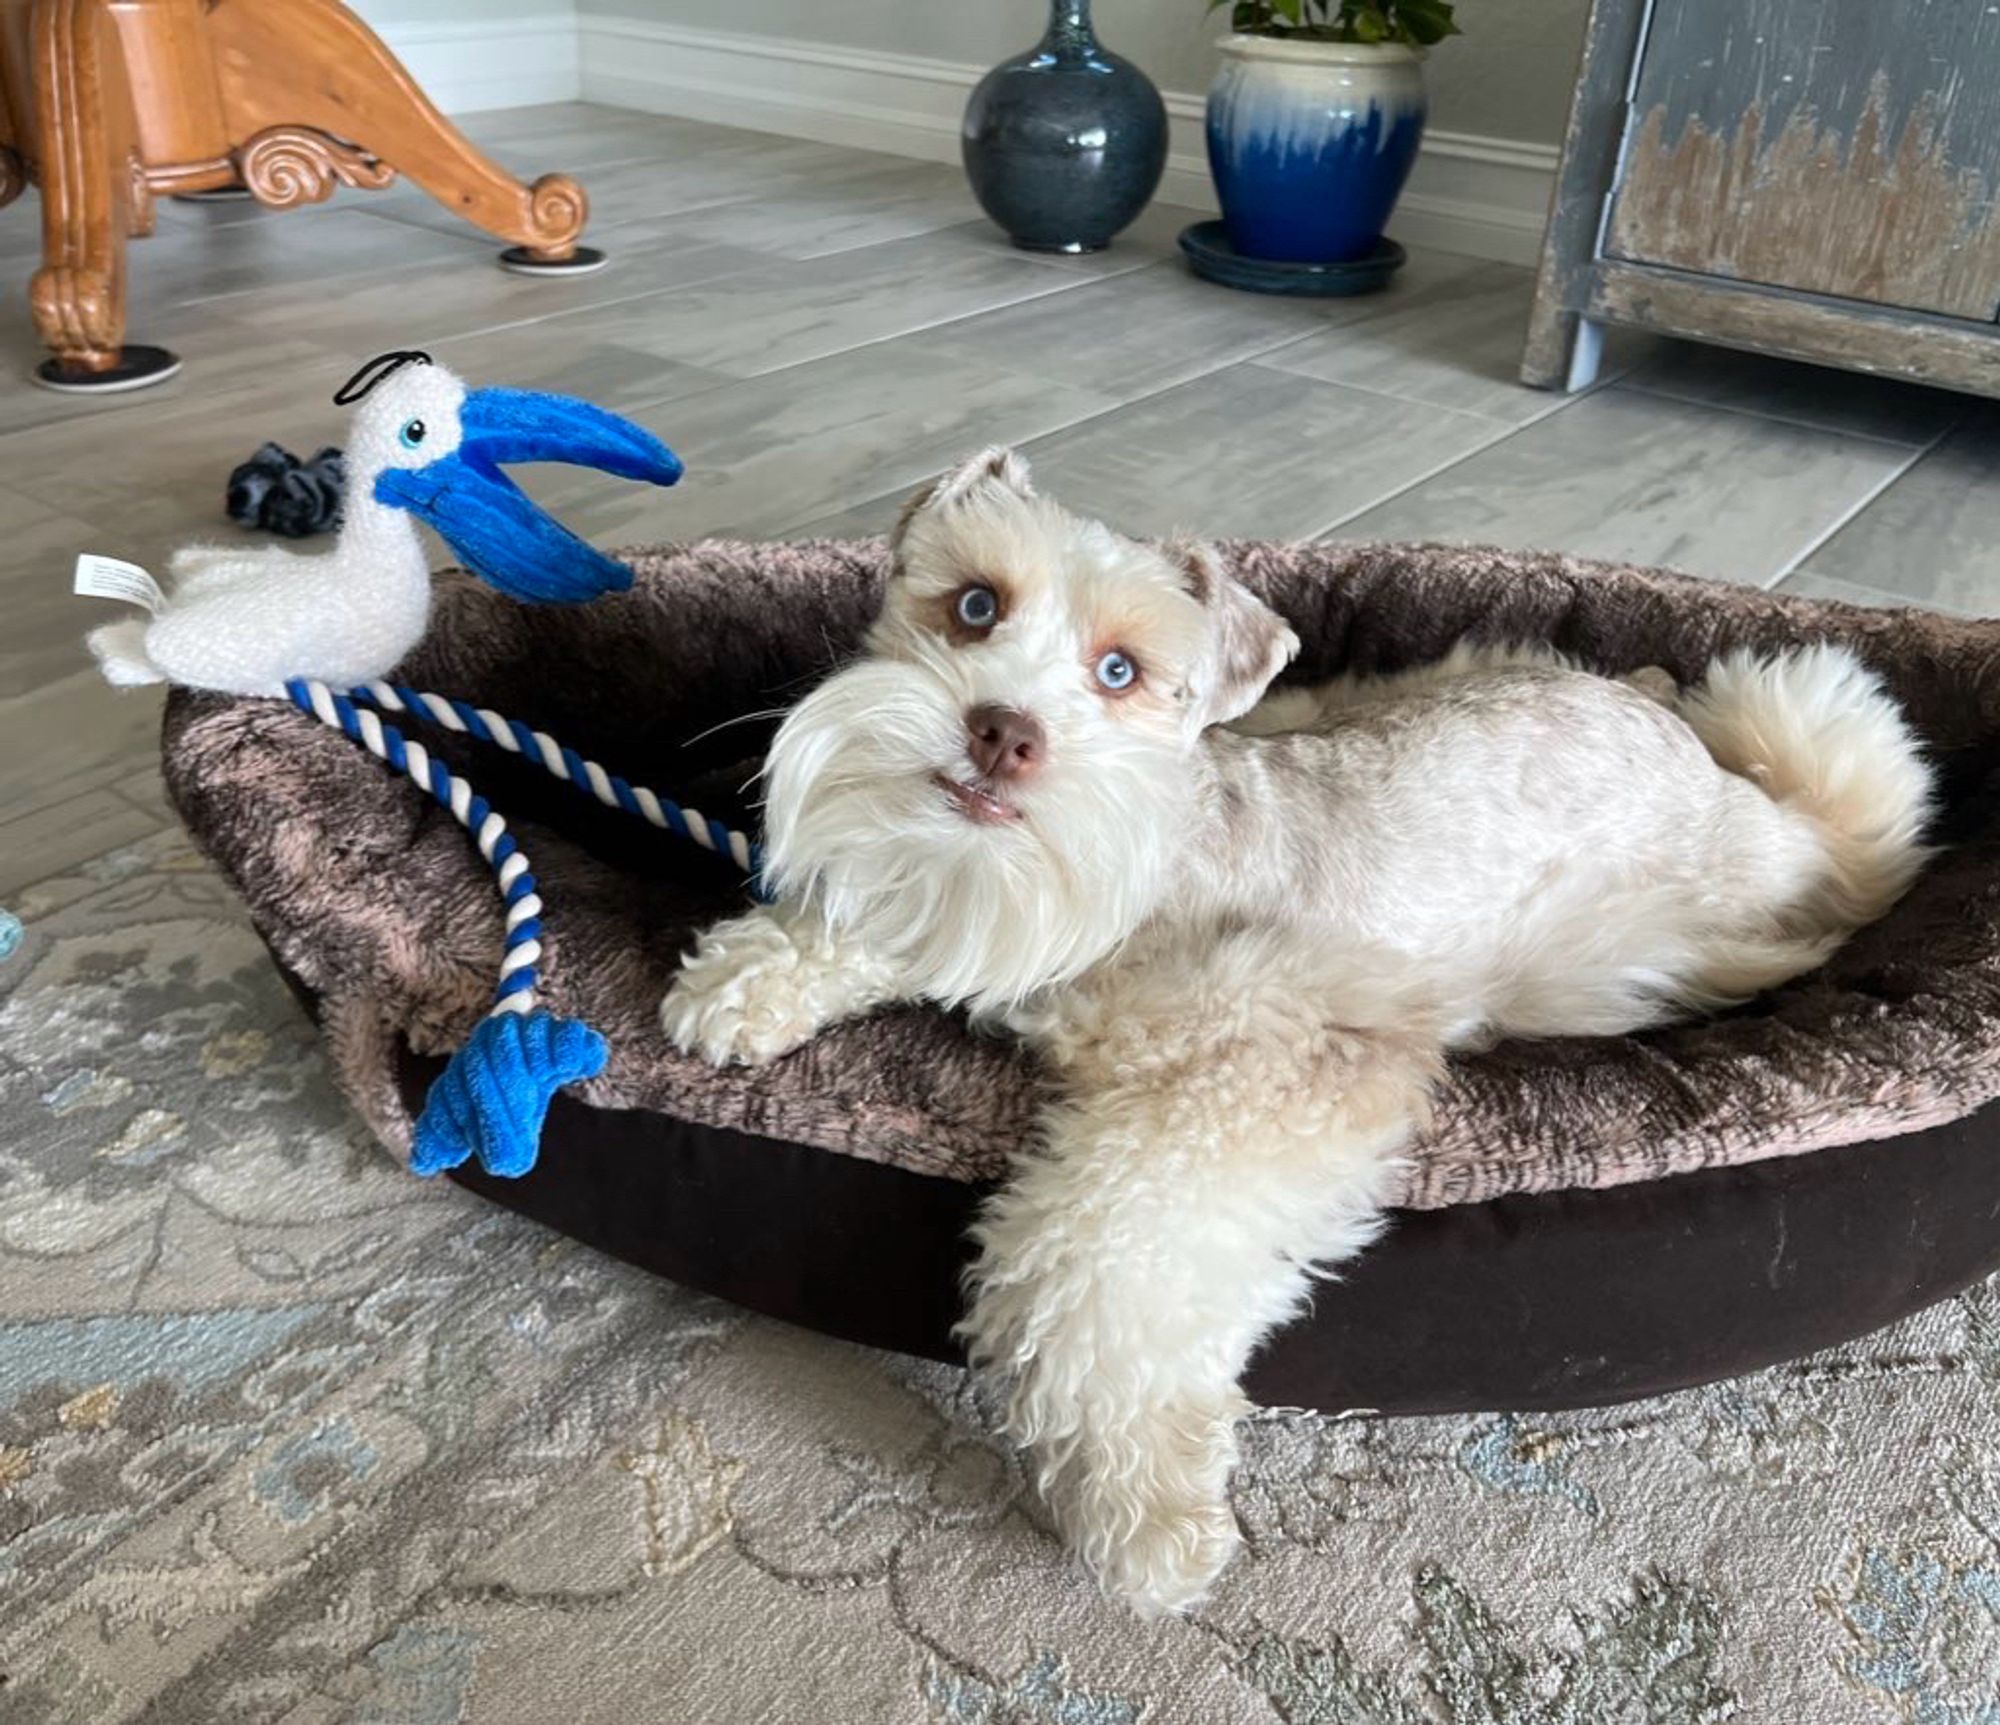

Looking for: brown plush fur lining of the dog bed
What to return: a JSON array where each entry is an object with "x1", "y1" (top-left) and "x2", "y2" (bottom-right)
[{"x1": 166, "y1": 540, "x2": 2000, "y2": 1405}]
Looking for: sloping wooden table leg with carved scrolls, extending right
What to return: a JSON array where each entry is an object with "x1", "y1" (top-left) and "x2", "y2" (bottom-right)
[{"x1": 204, "y1": 0, "x2": 604, "y2": 272}]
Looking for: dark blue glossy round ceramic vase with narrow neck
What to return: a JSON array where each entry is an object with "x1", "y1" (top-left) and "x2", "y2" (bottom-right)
[{"x1": 962, "y1": 0, "x2": 1166, "y2": 252}]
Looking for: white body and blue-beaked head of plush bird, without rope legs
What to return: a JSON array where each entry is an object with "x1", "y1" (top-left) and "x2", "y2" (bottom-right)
[{"x1": 90, "y1": 352, "x2": 680, "y2": 694}]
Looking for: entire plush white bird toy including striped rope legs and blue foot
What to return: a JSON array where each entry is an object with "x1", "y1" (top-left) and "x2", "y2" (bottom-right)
[{"x1": 80, "y1": 352, "x2": 696, "y2": 1175}]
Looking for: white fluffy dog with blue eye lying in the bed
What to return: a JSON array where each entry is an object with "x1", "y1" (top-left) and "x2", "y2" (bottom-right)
[{"x1": 662, "y1": 450, "x2": 1930, "y2": 1611}]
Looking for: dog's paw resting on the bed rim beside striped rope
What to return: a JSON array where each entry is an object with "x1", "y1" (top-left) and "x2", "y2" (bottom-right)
[{"x1": 660, "y1": 919, "x2": 822, "y2": 1067}]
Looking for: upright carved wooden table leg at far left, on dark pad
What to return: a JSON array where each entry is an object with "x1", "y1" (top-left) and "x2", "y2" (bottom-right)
[{"x1": 28, "y1": 0, "x2": 180, "y2": 390}]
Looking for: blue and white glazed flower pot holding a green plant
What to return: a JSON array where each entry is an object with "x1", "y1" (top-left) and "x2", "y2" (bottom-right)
[{"x1": 1208, "y1": 36, "x2": 1424, "y2": 264}]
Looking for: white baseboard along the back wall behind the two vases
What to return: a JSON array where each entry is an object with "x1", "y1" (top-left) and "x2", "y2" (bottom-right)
[{"x1": 578, "y1": 12, "x2": 1558, "y2": 264}]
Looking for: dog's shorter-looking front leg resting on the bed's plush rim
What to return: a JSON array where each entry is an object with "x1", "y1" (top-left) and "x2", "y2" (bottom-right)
[{"x1": 660, "y1": 905, "x2": 896, "y2": 1067}]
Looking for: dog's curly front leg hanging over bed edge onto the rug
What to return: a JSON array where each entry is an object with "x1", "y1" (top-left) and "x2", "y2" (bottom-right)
[{"x1": 962, "y1": 1025, "x2": 1436, "y2": 1615}]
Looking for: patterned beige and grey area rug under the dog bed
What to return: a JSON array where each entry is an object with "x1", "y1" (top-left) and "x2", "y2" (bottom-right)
[{"x1": 0, "y1": 834, "x2": 2000, "y2": 1725}]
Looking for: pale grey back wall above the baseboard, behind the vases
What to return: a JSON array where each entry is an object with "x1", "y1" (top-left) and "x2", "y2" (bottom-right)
[{"x1": 568, "y1": 0, "x2": 1590, "y2": 144}]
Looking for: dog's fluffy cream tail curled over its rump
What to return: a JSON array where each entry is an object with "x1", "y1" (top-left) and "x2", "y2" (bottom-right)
[{"x1": 1680, "y1": 644, "x2": 1932, "y2": 941}]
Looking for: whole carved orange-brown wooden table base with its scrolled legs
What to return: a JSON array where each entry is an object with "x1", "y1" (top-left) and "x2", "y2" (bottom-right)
[{"x1": 0, "y1": 0, "x2": 604, "y2": 390}]
